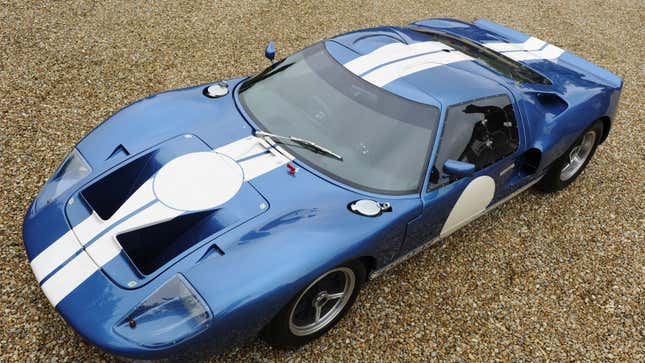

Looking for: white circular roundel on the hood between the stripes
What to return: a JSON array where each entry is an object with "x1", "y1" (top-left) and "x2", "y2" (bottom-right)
[{"x1": 153, "y1": 152, "x2": 244, "y2": 211}]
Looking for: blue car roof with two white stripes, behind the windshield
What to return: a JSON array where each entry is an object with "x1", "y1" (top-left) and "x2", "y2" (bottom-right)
[{"x1": 325, "y1": 27, "x2": 512, "y2": 107}]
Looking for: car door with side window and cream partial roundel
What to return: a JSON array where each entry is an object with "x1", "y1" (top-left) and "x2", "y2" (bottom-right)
[{"x1": 400, "y1": 95, "x2": 520, "y2": 254}]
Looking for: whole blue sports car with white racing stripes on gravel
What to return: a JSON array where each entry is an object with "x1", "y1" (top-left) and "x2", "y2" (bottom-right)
[{"x1": 23, "y1": 19, "x2": 622, "y2": 358}]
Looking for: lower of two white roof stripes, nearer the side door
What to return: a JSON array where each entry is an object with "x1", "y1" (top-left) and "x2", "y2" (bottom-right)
[{"x1": 363, "y1": 51, "x2": 472, "y2": 87}]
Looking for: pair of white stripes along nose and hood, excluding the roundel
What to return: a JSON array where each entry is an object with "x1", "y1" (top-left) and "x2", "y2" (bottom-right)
[{"x1": 31, "y1": 136, "x2": 293, "y2": 306}]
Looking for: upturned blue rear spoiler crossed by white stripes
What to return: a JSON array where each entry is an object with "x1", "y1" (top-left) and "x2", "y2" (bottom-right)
[{"x1": 473, "y1": 19, "x2": 623, "y2": 88}]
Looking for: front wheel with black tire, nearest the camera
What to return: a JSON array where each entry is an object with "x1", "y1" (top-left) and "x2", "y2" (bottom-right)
[{"x1": 260, "y1": 261, "x2": 367, "y2": 349}]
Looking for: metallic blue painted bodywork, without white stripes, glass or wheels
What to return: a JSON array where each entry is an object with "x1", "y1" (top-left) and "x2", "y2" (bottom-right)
[{"x1": 23, "y1": 19, "x2": 622, "y2": 358}]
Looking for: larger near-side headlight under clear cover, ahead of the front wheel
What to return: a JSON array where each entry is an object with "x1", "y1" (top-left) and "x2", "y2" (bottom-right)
[{"x1": 114, "y1": 274, "x2": 211, "y2": 347}]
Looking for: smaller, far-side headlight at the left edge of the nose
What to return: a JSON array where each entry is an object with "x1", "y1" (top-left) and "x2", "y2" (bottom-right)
[{"x1": 34, "y1": 149, "x2": 92, "y2": 210}]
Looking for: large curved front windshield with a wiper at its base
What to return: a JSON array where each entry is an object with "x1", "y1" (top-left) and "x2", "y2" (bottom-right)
[{"x1": 240, "y1": 43, "x2": 439, "y2": 194}]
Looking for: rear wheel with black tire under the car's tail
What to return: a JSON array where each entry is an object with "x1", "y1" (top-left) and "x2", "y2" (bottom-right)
[{"x1": 537, "y1": 121, "x2": 603, "y2": 193}]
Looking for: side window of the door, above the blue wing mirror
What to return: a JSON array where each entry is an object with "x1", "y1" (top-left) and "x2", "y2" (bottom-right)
[{"x1": 430, "y1": 95, "x2": 519, "y2": 189}]
